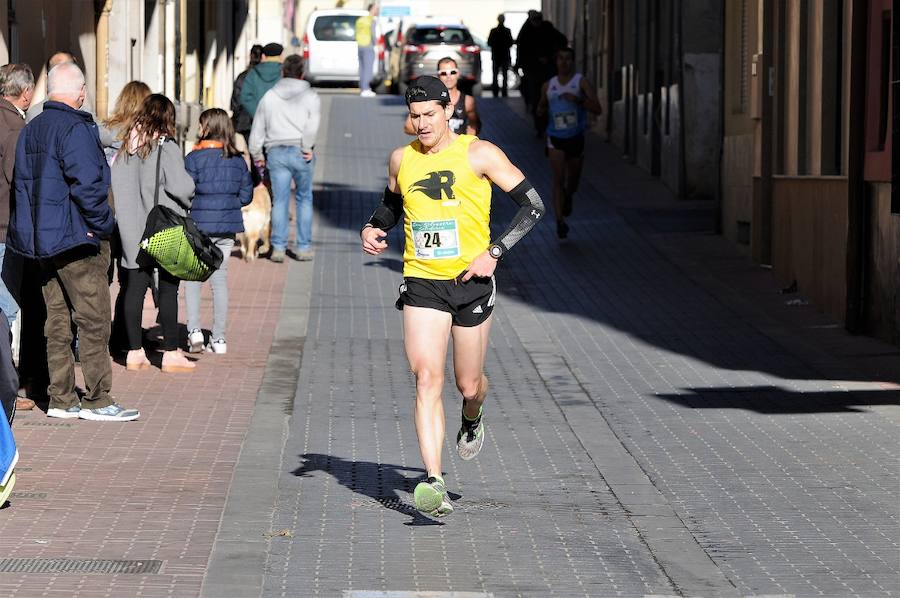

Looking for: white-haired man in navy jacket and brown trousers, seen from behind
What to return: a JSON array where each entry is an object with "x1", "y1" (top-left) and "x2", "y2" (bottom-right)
[{"x1": 7, "y1": 62, "x2": 140, "y2": 421}]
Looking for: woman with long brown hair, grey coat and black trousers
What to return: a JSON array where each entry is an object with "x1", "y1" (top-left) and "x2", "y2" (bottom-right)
[{"x1": 112, "y1": 94, "x2": 195, "y2": 372}]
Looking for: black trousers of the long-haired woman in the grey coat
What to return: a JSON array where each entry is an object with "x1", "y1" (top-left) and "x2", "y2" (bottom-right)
[{"x1": 122, "y1": 268, "x2": 180, "y2": 351}]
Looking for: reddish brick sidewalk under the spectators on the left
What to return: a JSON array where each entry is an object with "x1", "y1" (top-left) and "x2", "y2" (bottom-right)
[{"x1": 0, "y1": 252, "x2": 288, "y2": 597}]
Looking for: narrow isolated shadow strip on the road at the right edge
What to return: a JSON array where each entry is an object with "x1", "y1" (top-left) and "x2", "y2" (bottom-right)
[{"x1": 656, "y1": 386, "x2": 900, "y2": 415}]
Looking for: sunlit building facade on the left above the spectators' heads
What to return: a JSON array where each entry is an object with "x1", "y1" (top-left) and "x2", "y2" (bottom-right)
[{"x1": 0, "y1": 0, "x2": 290, "y2": 131}]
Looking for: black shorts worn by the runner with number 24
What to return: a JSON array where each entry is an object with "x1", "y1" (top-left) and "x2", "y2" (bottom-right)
[{"x1": 395, "y1": 276, "x2": 497, "y2": 328}]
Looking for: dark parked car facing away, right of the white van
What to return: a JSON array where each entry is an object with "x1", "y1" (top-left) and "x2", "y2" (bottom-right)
[{"x1": 391, "y1": 25, "x2": 481, "y2": 96}]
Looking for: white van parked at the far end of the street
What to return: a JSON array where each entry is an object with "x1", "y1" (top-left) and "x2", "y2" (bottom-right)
[{"x1": 303, "y1": 9, "x2": 384, "y2": 87}]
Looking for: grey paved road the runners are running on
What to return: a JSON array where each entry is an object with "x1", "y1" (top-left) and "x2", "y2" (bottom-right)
[{"x1": 204, "y1": 95, "x2": 900, "y2": 597}]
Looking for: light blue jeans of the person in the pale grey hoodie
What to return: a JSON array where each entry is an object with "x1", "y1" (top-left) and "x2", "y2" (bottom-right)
[{"x1": 266, "y1": 145, "x2": 316, "y2": 251}]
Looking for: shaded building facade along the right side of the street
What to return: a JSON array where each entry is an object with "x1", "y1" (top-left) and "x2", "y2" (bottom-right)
[{"x1": 543, "y1": 0, "x2": 900, "y2": 343}]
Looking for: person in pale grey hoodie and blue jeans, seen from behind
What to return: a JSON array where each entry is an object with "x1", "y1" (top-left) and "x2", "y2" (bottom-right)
[{"x1": 249, "y1": 55, "x2": 320, "y2": 262}]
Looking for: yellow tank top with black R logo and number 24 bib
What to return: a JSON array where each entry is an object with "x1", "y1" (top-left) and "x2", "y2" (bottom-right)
[{"x1": 397, "y1": 135, "x2": 491, "y2": 280}]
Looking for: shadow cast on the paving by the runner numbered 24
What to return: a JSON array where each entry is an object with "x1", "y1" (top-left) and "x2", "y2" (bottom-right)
[{"x1": 291, "y1": 453, "x2": 448, "y2": 526}]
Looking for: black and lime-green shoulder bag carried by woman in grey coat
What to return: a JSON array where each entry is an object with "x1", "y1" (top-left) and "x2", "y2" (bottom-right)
[{"x1": 141, "y1": 139, "x2": 224, "y2": 282}]
